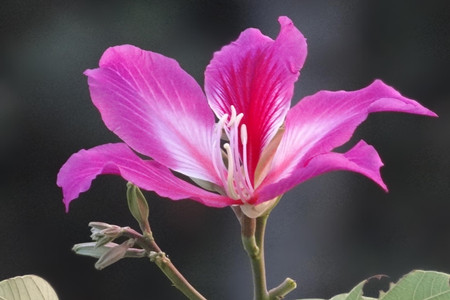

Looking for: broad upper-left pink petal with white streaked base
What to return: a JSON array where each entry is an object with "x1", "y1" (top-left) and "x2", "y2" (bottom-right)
[{"x1": 85, "y1": 45, "x2": 219, "y2": 183}]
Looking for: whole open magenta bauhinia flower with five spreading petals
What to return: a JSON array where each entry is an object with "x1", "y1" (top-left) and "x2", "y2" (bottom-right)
[{"x1": 57, "y1": 17, "x2": 436, "y2": 217}]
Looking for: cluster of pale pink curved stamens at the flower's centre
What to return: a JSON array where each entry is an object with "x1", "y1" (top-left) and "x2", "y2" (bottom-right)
[{"x1": 213, "y1": 106, "x2": 254, "y2": 202}]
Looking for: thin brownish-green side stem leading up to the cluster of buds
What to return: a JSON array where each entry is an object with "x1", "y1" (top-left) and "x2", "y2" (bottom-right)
[{"x1": 124, "y1": 228, "x2": 206, "y2": 300}]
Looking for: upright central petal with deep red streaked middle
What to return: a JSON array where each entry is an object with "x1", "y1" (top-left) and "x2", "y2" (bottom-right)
[{"x1": 205, "y1": 17, "x2": 306, "y2": 180}]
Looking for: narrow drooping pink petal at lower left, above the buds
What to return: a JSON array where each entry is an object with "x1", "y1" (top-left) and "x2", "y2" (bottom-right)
[{"x1": 57, "y1": 143, "x2": 236, "y2": 211}]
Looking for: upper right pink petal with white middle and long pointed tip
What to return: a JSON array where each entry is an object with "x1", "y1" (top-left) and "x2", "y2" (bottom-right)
[{"x1": 263, "y1": 80, "x2": 436, "y2": 184}]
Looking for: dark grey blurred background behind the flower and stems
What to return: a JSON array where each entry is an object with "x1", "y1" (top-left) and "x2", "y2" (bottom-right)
[{"x1": 0, "y1": 0, "x2": 450, "y2": 300}]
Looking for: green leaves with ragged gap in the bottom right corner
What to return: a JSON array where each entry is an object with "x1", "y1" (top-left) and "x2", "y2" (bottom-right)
[{"x1": 299, "y1": 270, "x2": 450, "y2": 300}]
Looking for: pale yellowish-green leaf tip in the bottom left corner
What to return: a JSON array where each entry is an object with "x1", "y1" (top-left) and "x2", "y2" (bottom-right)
[{"x1": 0, "y1": 275, "x2": 58, "y2": 300}]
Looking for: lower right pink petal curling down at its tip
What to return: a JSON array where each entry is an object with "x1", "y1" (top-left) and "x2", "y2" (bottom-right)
[{"x1": 255, "y1": 141, "x2": 387, "y2": 204}]
